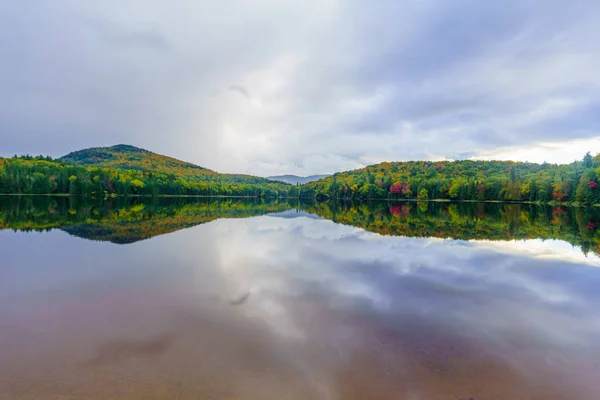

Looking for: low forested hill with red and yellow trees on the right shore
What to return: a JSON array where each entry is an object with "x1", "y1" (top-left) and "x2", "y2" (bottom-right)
[{"x1": 300, "y1": 153, "x2": 600, "y2": 204}]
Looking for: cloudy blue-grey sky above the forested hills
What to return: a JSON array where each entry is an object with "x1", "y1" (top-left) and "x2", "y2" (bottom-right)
[{"x1": 0, "y1": 0, "x2": 600, "y2": 176}]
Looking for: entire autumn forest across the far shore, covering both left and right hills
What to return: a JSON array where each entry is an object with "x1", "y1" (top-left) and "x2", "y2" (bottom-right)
[{"x1": 0, "y1": 145, "x2": 600, "y2": 205}]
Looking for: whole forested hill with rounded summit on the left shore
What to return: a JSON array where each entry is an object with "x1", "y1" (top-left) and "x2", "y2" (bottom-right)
[{"x1": 0, "y1": 145, "x2": 296, "y2": 197}]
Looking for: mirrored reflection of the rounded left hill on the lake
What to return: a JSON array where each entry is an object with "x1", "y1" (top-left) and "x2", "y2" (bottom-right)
[{"x1": 0, "y1": 197, "x2": 290, "y2": 244}]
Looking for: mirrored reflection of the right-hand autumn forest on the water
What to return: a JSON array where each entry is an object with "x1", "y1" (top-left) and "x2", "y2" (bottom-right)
[{"x1": 303, "y1": 202, "x2": 600, "y2": 254}]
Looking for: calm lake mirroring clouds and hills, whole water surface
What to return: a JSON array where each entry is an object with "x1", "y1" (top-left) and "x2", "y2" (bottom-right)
[{"x1": 0, "y1": 196, "x2": 600, "y2": 400}]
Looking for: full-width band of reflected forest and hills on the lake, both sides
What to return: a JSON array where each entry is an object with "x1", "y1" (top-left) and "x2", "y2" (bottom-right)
[{"x1": 0, "y1": 196, "x2": 600, "y2": 254}]
